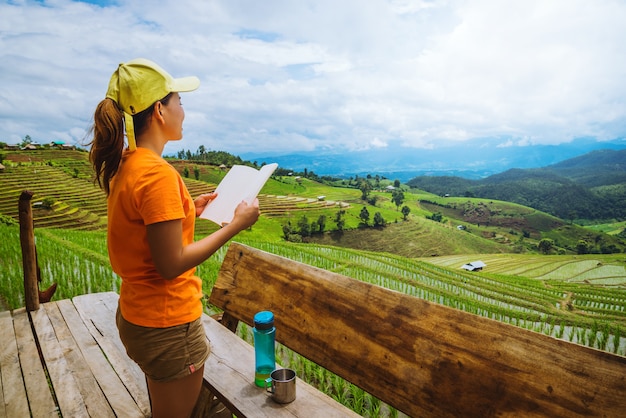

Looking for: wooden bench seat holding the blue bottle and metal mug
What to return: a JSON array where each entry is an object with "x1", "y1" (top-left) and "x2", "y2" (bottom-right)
[{"x1": 203, "y1": 315, "x2": 359, "y2": 418}]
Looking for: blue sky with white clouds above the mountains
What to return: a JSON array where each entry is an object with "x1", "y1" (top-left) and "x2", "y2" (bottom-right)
[{"x1": 0, "y1": 0, "x2": 626, "y2": 158}]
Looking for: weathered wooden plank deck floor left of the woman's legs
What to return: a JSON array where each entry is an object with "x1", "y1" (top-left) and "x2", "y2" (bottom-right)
[{"x1": 0, "y1": 293, "x2": 150, "y2": 418}]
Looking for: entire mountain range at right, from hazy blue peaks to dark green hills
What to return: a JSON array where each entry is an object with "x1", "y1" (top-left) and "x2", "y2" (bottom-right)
[{"x1": 243, "y1": 139, "x2": 626, "y2": 222}]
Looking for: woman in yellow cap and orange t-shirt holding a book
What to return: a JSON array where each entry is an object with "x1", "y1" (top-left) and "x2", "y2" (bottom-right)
[{"x1": 90, "y1": 59, "x2": 260, "y2": 418}]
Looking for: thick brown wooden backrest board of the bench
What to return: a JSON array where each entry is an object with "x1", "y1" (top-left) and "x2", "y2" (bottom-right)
[{"x1": 210, "y1": 243, "x2": 626, "y2": 416}]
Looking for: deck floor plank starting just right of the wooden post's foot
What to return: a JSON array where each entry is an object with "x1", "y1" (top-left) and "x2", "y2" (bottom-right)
[{"x1": 31, "y1": 302, "x2": 89, "y2": 417}]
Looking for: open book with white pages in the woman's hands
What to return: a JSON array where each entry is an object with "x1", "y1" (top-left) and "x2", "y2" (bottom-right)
[{"x1": 200, "y1": 163, "x2": 278, "y2": 226}]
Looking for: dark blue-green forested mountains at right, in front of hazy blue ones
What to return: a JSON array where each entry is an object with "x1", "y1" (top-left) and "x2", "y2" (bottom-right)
[{"x1": 407, "y1": 149, "x2": 626, "y2": 220}]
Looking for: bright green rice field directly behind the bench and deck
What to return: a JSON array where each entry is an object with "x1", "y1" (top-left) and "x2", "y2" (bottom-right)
[{"x1": 0, "y1": 220, "x2": 626, "y2": 355}]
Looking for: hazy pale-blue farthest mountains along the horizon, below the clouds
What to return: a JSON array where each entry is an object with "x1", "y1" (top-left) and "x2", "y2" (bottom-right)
[{"x1": 241, "y1": 139, "x2": 626, "y2": 183}]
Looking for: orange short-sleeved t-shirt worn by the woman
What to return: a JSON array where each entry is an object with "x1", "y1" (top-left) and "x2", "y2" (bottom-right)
[{"x1": 107, "y1": 148, "x2": 202, "y2": 328}]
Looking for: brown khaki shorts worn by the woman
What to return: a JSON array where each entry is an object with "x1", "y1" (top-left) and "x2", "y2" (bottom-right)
[{"x1": 116, "y1": 307, "x2": 210, "y2": 382}]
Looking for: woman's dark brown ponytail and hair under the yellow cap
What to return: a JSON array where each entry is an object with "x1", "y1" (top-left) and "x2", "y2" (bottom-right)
[{"x1": 89, "y1": 93, "x2": 172, "y2": 196}]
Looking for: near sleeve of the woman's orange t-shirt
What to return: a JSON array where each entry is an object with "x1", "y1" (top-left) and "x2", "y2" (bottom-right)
[{"x1": 135, "y1": 166, "x2": 185, "y2": 225}]
